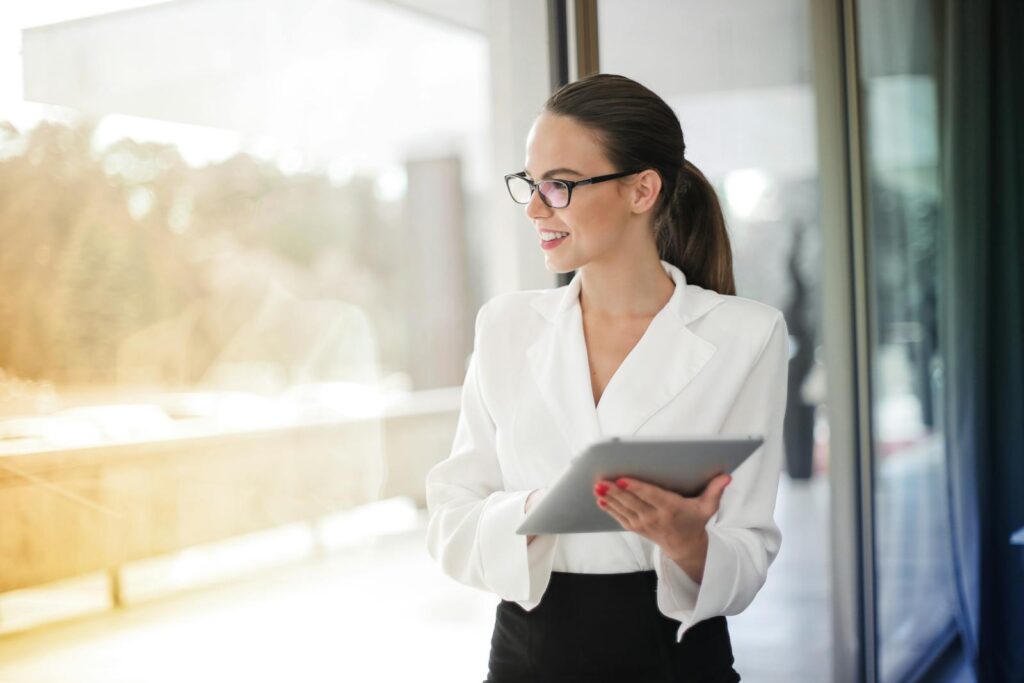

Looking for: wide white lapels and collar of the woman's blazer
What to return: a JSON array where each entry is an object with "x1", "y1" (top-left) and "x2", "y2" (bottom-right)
[{"x1": 526, "y1": 260, "x2": 724, "y2": 456}]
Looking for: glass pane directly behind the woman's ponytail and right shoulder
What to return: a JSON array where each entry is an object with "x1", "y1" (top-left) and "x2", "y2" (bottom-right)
[{"x1": 598, "y1": 0, "x2": 831, "y2": 681}]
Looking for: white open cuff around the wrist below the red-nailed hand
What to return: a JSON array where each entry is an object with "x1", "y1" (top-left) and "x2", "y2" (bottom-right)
[{"x1": 654, "y1": 524, "x2": 735, "y2": 642}]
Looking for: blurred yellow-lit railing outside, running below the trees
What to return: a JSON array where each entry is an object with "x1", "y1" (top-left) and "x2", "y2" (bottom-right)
[{"x1": 0, "y1": 387, "x2": 460, "y2": 603}]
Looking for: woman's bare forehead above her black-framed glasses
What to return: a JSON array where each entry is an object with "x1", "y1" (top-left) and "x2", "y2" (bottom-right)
[{"x1": 523, "y1": 113, "x2": 611, "y2": 178}]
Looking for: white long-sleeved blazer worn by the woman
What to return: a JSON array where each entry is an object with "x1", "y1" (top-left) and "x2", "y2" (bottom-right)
[{"x1": 426, "y1": 260, "x2": 788, "y2": 641}]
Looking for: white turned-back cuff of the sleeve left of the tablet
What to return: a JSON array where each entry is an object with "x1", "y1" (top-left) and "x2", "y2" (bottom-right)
[{"x1": 476, "y1": 490, "x2": 558, "y2": 609}]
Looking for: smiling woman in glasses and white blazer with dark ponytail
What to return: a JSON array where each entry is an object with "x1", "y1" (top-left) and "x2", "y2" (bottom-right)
[{"x1": 426, "y1": 74, "x2": 788, "y2": 683}]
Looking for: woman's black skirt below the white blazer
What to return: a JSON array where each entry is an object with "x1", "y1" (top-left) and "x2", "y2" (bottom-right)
[{"x1": 485, "y1": 569, "x2": 739, "y2": 683}]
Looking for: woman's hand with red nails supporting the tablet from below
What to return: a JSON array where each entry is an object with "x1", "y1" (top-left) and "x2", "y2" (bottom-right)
[{"x1": 594, "y1": 474, "x2": 732, "y2": 584}]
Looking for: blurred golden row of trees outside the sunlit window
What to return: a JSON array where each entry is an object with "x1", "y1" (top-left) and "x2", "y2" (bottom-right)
[{"x1": 0, "y1": 121, "x2": 403, "y2": 384}]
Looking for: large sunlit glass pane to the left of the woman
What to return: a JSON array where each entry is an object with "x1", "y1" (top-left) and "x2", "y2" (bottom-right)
[{"x1": 0, "y1": 0, "x2": 548, "y2": 681}]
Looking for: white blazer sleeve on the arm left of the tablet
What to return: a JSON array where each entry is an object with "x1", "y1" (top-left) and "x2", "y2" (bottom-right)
[{"x1": 426, "y1": 304, "x2": 558, "y2": 609}]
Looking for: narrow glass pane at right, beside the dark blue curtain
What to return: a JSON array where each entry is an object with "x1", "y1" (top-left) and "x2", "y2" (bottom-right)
[{"x1": 857, "y1": 0, "x2": 954, "y2": 681}]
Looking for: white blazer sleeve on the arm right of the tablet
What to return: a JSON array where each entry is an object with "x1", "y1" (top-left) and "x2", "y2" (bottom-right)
[{"x1": 653, "y1": 312, "x2": 790, "y2": 641}]
